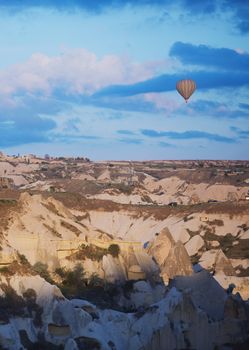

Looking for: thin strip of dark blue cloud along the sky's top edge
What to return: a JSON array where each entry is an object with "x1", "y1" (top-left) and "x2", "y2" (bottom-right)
[{"x1": 0, "y1": 0, "x2": 249, "y2": 34}]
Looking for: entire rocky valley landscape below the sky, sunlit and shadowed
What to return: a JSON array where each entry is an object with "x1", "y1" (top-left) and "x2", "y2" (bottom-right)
[{"x1": 0, "y1": 158, "x2": 249, "y2": 350}]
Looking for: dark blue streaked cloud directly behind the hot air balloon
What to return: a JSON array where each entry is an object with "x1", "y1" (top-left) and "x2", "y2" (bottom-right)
[{"x1": 96, "y1": 42, "x2": 249, "y2": 96}]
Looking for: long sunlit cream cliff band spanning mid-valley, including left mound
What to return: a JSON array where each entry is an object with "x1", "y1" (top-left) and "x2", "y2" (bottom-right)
[{"x1": 0, "y1": 193, "x2": 249, "y2": 277}]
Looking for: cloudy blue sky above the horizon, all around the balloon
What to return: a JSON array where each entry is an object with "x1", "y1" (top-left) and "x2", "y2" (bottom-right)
[{"x1": 0, "y1": 0, "x2": 249, "y2": 160}]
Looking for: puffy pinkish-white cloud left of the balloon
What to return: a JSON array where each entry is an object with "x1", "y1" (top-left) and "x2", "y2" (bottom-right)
[{"x1": 0, "y1": 49, "x2": 161, "y2": 95}]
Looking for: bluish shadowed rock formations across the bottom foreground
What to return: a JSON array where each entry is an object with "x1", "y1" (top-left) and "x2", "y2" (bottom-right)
[{"x1": 0, "y1": 271, "x2": 248, "y2": 350}]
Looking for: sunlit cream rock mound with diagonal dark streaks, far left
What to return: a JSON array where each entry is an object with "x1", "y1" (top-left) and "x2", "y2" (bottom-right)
[{"x1": 6, "y1": 193, "x2": 85, "y2": 268}]
